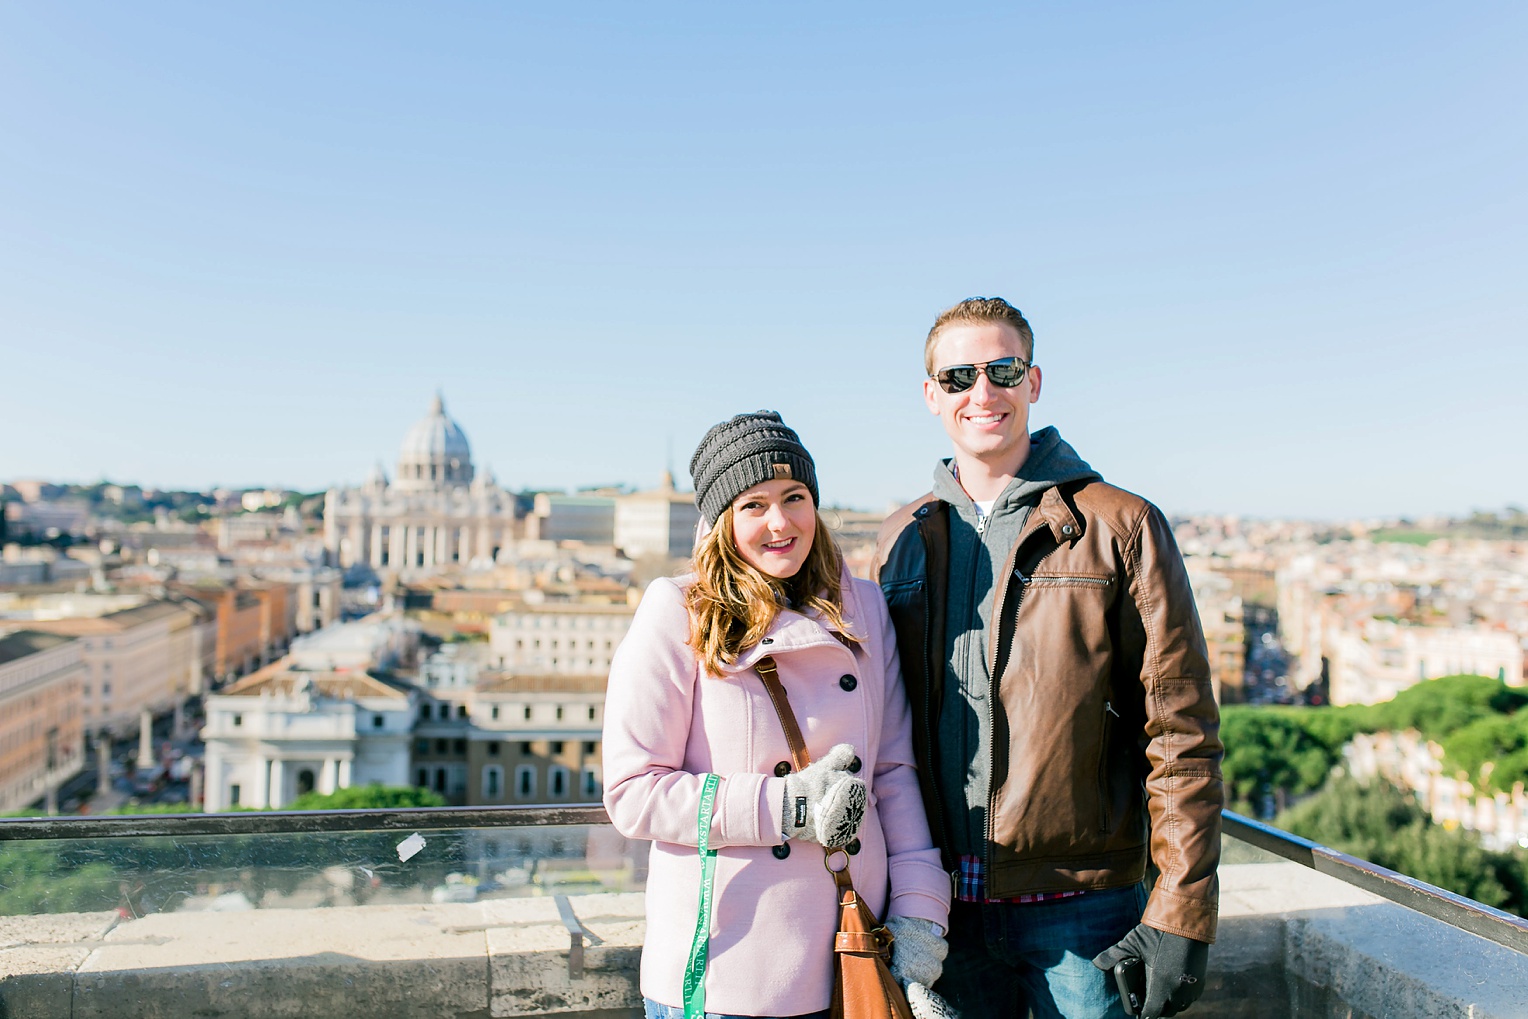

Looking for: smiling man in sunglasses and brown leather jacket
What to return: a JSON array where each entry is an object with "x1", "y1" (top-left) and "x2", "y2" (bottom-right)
[{"x1": 874, "y1": 298, "x2": 1222, "y2": 1019}]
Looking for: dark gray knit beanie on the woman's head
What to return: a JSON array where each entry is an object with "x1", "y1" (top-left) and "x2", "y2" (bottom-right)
[{"x1": 689, "y1": 411, "x2": 821, "y2": 524}]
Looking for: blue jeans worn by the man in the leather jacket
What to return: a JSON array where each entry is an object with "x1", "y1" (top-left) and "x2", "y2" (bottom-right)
[{"x1": 934, "y1": 885, "x2": 1146, "y2": 1019}]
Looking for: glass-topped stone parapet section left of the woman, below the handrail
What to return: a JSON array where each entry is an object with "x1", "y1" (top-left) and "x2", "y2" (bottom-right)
[{"x1": 0, "y1": 825, "x2": 648, "y2": 1019}]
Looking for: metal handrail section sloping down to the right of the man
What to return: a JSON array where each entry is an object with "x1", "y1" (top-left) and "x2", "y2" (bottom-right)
[{"x1": 1224, "y1": 810, "x2": 1528, "y2": 955}]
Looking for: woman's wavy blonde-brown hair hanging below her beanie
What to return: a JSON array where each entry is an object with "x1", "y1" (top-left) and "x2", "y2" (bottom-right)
[{"x1": 685, "y1": 506, "x2": 859, "y2": 677}]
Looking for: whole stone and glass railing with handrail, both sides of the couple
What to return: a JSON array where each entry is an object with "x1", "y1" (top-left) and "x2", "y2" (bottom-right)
[{"x1": 0, "y1": 807, "x2": 1528, "y2": 1019}]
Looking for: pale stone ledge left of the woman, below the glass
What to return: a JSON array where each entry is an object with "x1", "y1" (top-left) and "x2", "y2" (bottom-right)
[{"x1": 0, "y1": 894, "x2": 643, "y2": 1019}]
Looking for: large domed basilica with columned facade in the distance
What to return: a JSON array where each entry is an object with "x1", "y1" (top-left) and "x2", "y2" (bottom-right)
[{"x1": 324, "y1": 394, "x2": 523, "y2": 571}]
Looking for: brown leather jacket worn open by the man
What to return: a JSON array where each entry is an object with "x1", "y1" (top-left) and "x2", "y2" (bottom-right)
[{"x1": 874, "y1": 481, "x2": 1222, "y2": 941}]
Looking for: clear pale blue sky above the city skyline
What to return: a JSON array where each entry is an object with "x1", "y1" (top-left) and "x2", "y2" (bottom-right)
[{"x1": 0, "y1": 3, "x2": 1528, "y2": 518}]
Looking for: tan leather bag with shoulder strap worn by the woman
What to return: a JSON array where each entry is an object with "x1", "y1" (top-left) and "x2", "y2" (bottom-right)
[{"x1": 755, "y1": 655, "x2": 912, "y2": 1019}]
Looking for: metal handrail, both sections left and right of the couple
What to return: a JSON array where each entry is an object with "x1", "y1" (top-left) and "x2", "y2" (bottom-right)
[{"x1": 0, "y1": 804, "x2": 1528, "y2": 955}]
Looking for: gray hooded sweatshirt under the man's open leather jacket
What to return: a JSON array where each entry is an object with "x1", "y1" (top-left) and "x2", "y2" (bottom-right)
[{"x1": 934, "y1": 428, "x2": 1102, "y2": 856}]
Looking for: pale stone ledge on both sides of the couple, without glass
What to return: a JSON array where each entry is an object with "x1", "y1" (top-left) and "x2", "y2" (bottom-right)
[{"x1": 0, "y1": 862, "x2": 1528, "y2": 1019}]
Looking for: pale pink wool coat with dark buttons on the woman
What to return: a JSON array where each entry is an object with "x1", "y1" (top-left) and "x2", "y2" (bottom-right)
[{"x1": 604, "y1": 573, "x2": 950, "y2": 1016}]
